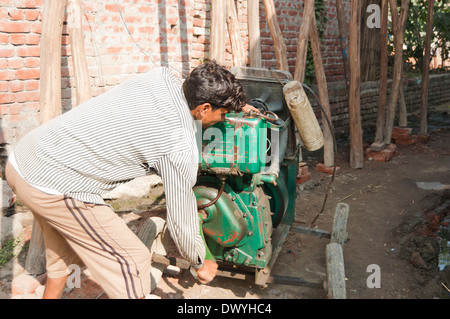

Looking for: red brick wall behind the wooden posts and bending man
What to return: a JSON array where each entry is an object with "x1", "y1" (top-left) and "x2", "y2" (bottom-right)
[{"x1": 0, "y1": 0, "x2": 450, "y2": 149}]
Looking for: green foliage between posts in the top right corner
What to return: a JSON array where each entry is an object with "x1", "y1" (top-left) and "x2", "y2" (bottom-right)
[{"x1": 403, "y1": 0, "x2": 450, "y2": 72}]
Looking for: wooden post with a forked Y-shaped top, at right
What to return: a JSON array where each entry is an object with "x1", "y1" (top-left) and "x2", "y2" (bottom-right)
[{"x1": 384, "y1": 0, "x2": 410, "y2": 144}]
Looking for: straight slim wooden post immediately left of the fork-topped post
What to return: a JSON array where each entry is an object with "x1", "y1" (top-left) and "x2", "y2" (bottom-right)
[{"x1": 371, "y1": 0, "x2": 389, "y2": 151}]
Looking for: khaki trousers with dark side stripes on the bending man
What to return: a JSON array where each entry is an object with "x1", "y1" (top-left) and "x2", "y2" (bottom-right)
[{"x1": 5, "y1": 162, "x2": 151, "y2": 298}]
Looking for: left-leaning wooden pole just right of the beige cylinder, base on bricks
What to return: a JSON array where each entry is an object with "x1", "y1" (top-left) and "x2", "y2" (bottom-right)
[{"x1": 306, "y1": 13, "x2": 334, "y2": 167}]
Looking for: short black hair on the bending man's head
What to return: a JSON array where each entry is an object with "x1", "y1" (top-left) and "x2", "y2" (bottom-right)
[{"x1": 183, "y1": 61, "x2": 247, "y2": 112}]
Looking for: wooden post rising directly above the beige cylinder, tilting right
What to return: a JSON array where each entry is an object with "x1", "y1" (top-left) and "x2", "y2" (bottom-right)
[{"x1": 294, "y1": 0, "x2": 314, "y2": 83}]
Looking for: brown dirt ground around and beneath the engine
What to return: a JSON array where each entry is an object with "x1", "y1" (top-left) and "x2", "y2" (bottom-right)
[{"x1": 0, "y1": 107, "x2": 450, "y2": 299}]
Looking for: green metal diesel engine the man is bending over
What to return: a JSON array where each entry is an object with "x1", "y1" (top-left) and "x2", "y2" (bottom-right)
[{"x1": 194, "y1": 69, "x2": 299, "y2": 280}]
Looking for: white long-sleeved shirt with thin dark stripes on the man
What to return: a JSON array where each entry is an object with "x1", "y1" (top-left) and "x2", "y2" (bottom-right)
[{"x1": 14, "y1": 68, "x2": 205, "y2": 267}]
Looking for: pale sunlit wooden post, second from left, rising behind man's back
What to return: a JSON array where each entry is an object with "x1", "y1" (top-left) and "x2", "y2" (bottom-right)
[{"x1": 67, "y1": 0, "x2": 91, "y2": 105}]
